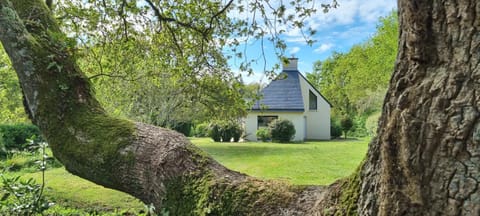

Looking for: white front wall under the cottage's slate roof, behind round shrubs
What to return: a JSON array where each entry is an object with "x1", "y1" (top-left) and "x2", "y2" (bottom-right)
[{"x1": 245, "y1": 111, "x2": 308, "y2": 141}]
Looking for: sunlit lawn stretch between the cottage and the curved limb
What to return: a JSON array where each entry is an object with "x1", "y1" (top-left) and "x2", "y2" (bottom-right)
[{"x1": 190, "y1": 138, "x2": 369, "y2": 185}]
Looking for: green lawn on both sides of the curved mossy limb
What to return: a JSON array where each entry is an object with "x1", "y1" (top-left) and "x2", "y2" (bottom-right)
[{"x1": 2, "y1": 138, "x2": 368, "y2": 213}]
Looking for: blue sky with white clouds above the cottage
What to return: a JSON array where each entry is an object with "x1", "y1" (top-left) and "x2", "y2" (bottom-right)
[{"x1": 229, "y1": 0, "x2": 397, "y2": 83}]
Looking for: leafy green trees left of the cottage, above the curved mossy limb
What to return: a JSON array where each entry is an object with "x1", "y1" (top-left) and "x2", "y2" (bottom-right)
[{"x1": 54, "y1": 1, "x2": 249, "y2": 128}]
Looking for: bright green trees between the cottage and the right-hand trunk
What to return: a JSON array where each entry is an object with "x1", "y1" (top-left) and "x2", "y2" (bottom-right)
[{"x1": 307, "y1": 11, "x2": 398, "y2": 135}]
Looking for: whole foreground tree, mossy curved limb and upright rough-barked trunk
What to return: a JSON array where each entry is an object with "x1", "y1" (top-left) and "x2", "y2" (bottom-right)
[{"x1": 0, "y1": 0, "x2": 480, "y2": 215}]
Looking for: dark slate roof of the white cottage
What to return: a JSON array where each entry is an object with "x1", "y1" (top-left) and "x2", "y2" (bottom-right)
[{"x1": 252, "y1": 70, "x2": 305, "y2": 112}]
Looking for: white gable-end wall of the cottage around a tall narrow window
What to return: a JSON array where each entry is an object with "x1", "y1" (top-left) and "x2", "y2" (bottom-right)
[{"x1": 300, "y1": 76, "x2": 330, "y2": 140}]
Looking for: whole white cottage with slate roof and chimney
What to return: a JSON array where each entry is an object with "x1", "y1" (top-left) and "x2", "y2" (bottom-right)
[{"x1": 245, "y1": 58, "x2": 331, "y2": 141}]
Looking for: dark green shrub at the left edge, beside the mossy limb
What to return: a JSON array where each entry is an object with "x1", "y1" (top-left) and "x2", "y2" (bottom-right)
[{"x1": 0, "y1": 124, "x2": 43, "y2": 151}]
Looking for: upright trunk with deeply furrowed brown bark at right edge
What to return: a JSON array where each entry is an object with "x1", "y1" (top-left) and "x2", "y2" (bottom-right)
[{"x1": 358, "y1": 0, "x2": 480, "y2": 215}]
